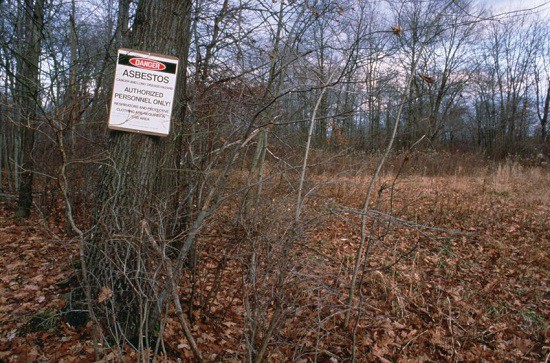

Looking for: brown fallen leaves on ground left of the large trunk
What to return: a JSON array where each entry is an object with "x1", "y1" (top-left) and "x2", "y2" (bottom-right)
[{"x1": 0, "y1": 203, "x2": 93, "y2": 362}]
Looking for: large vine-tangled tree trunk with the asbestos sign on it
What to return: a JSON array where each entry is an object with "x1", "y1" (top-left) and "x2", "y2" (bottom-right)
[{"x1": 86, "y1": 0, "x2": 191, "y2": 348}]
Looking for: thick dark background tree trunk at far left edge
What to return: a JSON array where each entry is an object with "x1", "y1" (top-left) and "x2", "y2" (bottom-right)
[{"x1": 15, "y1": 0, "x2": 44, "y2": 218}]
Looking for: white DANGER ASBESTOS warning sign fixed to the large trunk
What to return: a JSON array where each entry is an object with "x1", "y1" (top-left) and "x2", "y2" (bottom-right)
[{"x1": 109, "y1": 48, "x2": 178, "y2": 136}]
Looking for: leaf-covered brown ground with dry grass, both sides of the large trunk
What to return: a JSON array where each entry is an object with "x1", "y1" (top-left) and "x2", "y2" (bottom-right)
[{"x1": 0, "y1": 156, "x2": 550, "y2": 362}]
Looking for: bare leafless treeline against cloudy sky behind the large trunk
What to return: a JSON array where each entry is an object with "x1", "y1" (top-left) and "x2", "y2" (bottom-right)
[{"x1": 0, "y1": 0, "x2": 550, "y2": 195}]
